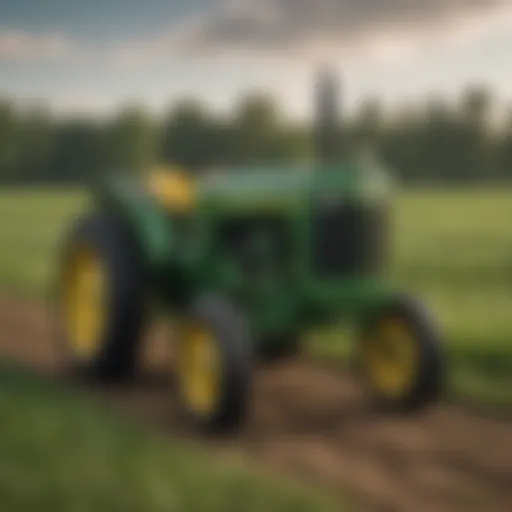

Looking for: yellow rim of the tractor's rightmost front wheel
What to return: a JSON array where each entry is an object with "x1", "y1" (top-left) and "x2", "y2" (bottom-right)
[{"x1": 364, "y1": 318, "x2": 419, "y2": 398}]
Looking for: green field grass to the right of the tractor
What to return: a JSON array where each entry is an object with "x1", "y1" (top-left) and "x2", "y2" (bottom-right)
[{"x1": 396, "y1": 190, "x2": 512, "y2": 406}]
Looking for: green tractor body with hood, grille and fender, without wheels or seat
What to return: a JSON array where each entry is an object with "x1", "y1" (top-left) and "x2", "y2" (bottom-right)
[{"x1": 97, "y1": 156, "x2": 391, "y2": 352}]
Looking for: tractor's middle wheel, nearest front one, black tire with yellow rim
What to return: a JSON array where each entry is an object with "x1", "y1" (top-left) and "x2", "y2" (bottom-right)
[{"x1": 177, "y1": 295, "x2": 253, "y2": 433}]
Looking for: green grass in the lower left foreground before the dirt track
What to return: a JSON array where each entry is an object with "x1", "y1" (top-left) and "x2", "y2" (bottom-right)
[{"x1": 0, "y1": 366, "x2": 340, "y2": 512}]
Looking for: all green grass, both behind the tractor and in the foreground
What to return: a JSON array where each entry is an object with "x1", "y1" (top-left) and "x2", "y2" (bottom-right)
[{"x1": 0, "y1": 189, "x2": 512, "y2": 512}]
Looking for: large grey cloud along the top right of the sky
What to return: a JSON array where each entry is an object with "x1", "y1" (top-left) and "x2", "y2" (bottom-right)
[{"x1": 188, "y1": 0, "x2": 510, "y2": 50}]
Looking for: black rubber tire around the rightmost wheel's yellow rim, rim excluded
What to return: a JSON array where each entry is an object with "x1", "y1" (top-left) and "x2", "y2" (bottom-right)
[{"x1": 355, "y1": 296, "x2": 444, "y2": 413}]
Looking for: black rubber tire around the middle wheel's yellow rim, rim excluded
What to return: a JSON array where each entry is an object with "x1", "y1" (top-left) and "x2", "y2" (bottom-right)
[{"x1": 181, "y1": 295, "x2": 253, "y2": 434}]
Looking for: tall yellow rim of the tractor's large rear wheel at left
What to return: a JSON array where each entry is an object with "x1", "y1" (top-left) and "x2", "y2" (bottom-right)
[{"x1": 62, "y1": 247, "x2": 106, "y2": 360}]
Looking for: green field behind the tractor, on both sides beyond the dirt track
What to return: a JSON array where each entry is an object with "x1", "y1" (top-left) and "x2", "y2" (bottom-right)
[{"x1": 0, "y1": 189, "x2": 512, "y2": 407}]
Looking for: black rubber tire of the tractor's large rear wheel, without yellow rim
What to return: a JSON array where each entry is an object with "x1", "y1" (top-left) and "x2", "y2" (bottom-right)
[{"x1": 56, "y1": 213, "x2": 146, "y2": 382}]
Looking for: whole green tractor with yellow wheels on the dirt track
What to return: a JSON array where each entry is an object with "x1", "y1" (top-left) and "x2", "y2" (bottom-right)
[{"x1": 54, "y1": 72, "x2": 442, "y2": 431}]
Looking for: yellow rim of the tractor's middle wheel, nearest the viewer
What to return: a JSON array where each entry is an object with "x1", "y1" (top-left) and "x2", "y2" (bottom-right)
[{"x1": 179, "y1": 324, "x2": 221, "y2": 416}]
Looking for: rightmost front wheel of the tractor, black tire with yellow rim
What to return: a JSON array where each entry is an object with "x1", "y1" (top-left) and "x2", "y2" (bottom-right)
[{"x1": 356, "y1": 297, "x2": 443, "y2": 412}]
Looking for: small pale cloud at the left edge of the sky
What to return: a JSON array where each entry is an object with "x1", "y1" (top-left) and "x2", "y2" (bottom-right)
[{"x1": 0, "y1": 28, "x2": 72, "y2": 61}]
